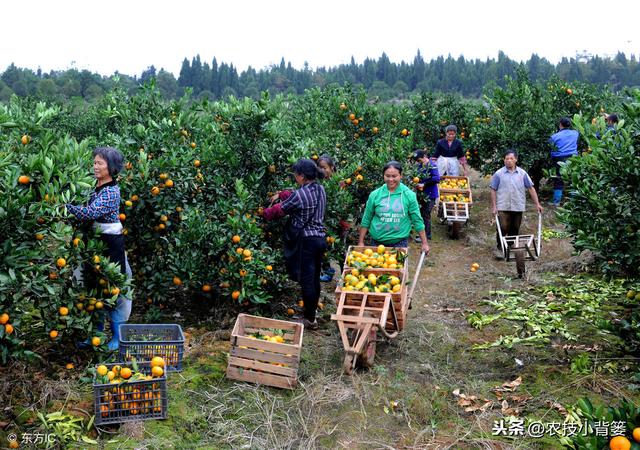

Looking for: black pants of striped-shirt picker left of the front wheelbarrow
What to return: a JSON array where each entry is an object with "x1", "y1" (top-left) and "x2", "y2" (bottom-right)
[{"x1": 300, "y1": 236, "x2": 327, "y2": 322}]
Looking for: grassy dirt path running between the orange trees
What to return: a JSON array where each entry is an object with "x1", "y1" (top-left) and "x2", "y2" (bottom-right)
[{"x1": 94, "y1": 175, "x2": 584, "y2": 449}]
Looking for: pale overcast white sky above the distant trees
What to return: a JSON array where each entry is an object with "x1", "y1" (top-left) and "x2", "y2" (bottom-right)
[{"x1": 0, "y1": 0, "x2": 640, "y2": 76}]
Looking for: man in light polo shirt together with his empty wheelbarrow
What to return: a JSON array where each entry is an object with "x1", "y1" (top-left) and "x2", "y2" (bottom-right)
[{"x1": 489, "y1": 149, "x2": 542, "y2": 276}]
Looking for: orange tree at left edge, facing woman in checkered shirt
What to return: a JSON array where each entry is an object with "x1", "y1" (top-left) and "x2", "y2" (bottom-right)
[{"x1": 0, "y1": 99, "x2": 128, "y2": 362}]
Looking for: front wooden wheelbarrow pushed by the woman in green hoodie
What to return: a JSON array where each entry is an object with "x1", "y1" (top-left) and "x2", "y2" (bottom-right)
[{"x1": 331, "y1": 252, "x2": 426, "y2": 375}]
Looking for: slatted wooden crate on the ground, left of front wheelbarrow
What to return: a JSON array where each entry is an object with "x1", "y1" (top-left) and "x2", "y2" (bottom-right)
[{"x1": 227, "y1": 314, "x2": 304, "y2": 389}]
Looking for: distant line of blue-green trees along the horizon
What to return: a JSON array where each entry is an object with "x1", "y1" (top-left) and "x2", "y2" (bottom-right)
[{"x1": 0, "y1": 51, "x2": 640, "y2": 101}]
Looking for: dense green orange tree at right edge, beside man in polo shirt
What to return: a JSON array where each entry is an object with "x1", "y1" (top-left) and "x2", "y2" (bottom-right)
[{"x1": 560, "y1": 90, "x2": 640, "y2": 275}]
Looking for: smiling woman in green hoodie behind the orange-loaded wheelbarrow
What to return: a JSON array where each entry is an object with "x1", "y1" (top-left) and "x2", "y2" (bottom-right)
[{"x1": 358, "y1": 161, "x2": 429, "y2": 253}]
